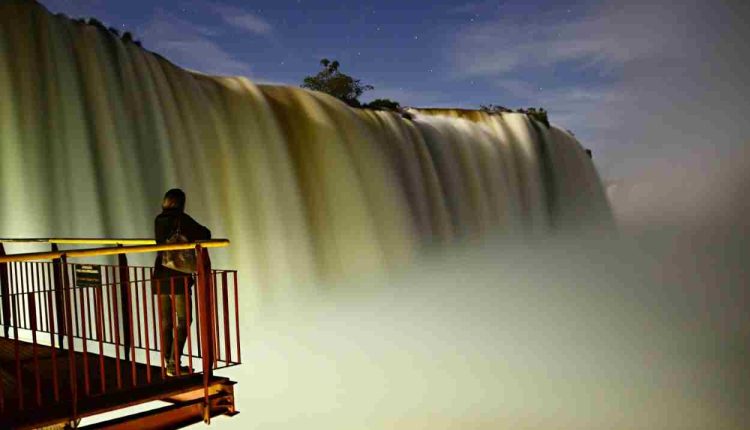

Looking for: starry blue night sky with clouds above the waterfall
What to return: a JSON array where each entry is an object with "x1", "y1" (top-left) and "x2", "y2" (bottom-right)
[{"x1": 41, "y1": 0, "x2": 750, "y2": 185}]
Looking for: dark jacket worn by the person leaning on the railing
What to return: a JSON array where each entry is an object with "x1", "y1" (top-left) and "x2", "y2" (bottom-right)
[{"x1": 151, "y1": 209, "x2": 211, "y2": 294}]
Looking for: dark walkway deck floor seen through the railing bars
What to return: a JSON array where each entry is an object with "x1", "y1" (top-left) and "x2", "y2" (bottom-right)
[{"x1": 0, "y1": 338, "x2": 229, "y2": 428}]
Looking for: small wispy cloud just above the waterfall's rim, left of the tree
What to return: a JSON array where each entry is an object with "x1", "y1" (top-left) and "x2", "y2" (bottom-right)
[{"x1": 143, "y1": 10, "x2": 252, "y2": 76}]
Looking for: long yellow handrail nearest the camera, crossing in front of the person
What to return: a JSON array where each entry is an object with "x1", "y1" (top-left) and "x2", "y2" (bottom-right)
[{"x1": 0, "y1": 239, "x2": 229, "y2": 263}]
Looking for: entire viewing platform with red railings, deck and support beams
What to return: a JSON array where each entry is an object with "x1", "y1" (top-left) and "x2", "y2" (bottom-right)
[{"x1": 0, "y1": 239, "x2": 241, "y2": 429}]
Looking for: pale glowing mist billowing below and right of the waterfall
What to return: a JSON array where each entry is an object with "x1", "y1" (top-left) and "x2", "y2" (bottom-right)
[{"x1": 207, "y1": 143, "x2": 750, "y2": 429}]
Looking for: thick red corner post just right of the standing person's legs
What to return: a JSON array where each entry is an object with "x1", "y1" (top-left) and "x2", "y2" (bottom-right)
[{"x1": 195, "y1": 245, "x2": 214, "y2": 423}]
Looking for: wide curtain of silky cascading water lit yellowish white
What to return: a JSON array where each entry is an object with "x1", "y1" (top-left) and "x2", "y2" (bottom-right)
[{"x1": 0, "y1": 1, "x2": 611, "y2": 306}]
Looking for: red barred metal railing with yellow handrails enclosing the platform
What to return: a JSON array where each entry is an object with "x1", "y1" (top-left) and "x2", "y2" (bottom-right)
[{"x1": 0, "y1": 239, "x2": 241, "y2": 424}]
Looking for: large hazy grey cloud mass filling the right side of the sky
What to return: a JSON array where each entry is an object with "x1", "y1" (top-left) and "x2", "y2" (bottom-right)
[{"x1": 448, "y1": 0, "x2": 750, "y2": 178}]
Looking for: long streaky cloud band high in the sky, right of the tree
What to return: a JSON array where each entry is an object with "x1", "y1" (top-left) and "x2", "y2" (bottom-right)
[{"x1": 454, "y1": 6, "x2": 681, "y2": 76}]
